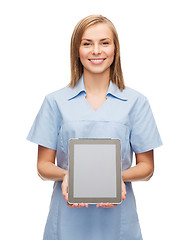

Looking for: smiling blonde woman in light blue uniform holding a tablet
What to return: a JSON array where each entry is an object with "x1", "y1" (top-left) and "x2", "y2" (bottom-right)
[{"x1": 28, "y1": 15, "x2": 162, "y2": 240}]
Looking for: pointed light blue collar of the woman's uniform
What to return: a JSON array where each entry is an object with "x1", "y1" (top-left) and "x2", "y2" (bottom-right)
[{"x1": 68, "y1": 75, "x2": 128, "y2": 101}]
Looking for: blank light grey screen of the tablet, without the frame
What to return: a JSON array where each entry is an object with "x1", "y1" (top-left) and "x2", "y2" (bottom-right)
[{"x1": 73, "y1": 144, "x2": 116, "y2": 198}]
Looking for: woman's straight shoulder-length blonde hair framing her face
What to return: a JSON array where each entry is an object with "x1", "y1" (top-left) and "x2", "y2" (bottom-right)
[{"x1": 68, "y1": 15, "x2": 125, "y2": 91}]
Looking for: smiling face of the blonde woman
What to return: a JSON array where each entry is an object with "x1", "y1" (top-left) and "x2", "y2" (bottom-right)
[{"x1": 79, "y1": 23, "x2": 115, "y2": 74}]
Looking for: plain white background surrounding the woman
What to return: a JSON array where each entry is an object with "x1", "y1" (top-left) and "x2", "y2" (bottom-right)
[{"x1": 0, "y1": 0, "x2": 192, "y2": 240}]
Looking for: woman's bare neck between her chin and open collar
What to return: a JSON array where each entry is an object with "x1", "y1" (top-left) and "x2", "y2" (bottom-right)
[{"x1": 83, "y1": 70, "x2": 110, "y2": 95}]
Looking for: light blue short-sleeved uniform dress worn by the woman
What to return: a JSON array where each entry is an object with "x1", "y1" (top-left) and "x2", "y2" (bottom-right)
[{"x1": 27, "y1": 75, "x2": 162, "y2": 240}]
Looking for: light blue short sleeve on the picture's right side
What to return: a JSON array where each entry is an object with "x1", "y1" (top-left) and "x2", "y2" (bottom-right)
[{"x1": 130, "y1": 96, "x2": 162, "y2": 153}]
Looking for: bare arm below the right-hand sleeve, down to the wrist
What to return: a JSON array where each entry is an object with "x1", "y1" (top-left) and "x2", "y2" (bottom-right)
[{"x1": 122, "y1": 150, "x2": 154, "y2": 182}]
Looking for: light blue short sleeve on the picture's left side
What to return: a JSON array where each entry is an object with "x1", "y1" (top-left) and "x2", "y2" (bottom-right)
[{"x1": 27, "y1": 96, "x2": 60, "y2": 150}]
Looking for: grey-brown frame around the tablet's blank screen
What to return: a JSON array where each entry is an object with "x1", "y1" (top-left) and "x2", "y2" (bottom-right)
[{"x1": 68, "y1": 138, "x2": 122, "y2": 204}]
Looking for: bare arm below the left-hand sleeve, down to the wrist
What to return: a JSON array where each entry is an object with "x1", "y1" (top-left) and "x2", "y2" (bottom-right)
[{"x1": 37, "y1": 145, "x2": 67, "y2": 181}]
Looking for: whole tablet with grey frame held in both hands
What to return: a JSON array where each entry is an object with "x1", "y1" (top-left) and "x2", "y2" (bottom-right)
[{"x1": 68, "y1": 138, "x2": 122, "y2": 204}]
